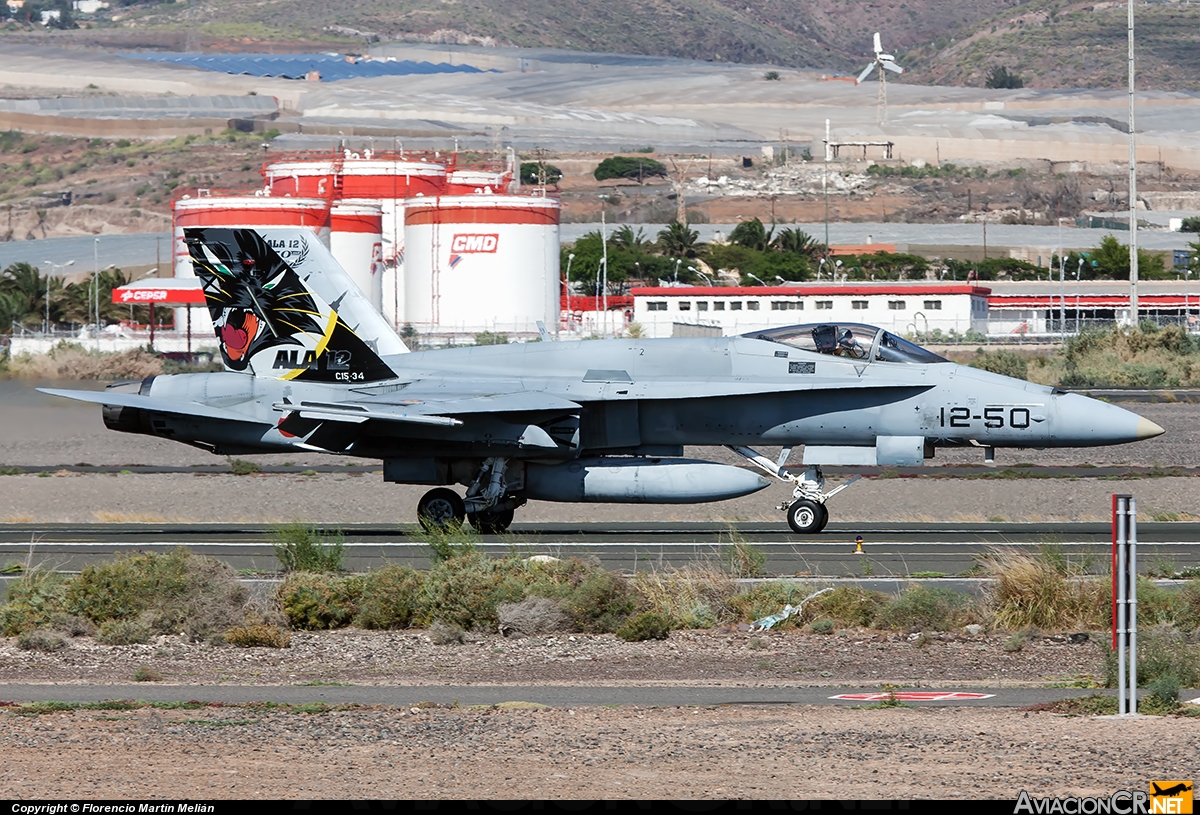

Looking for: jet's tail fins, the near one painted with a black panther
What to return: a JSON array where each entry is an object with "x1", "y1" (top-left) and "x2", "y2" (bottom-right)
[{"x1": 184, "y1": 228, "x2": 407, "y2": 383}]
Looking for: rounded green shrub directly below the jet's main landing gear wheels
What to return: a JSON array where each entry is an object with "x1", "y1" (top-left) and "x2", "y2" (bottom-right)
[{"x1": 414, "y1": 552, "x2": 532, "y2": 630}]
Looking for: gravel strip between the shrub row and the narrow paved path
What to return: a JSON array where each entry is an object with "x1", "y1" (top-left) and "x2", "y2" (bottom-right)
[{"x1": 0, "y1": 629, "x2": 1104, "y2": 686}]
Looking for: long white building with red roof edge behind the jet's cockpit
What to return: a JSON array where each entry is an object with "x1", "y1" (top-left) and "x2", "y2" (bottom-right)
[{"x1": 631, "y1": 282, "x2": 990, "y2": 337}]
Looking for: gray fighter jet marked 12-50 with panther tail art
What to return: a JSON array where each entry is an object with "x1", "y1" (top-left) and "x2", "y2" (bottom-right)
[{"x1": 44, "y1": 228, "x2": 1163, "y2": 534}]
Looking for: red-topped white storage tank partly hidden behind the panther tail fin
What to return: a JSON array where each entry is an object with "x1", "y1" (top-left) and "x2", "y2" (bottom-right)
[{"x1": 172, "y1": 194, "x2": 329, "y2": 334}]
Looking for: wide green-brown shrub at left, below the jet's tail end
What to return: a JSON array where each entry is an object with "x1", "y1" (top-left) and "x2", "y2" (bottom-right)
[{"x1": 65, "y1": 549, "x2": 247, "y2": 641}]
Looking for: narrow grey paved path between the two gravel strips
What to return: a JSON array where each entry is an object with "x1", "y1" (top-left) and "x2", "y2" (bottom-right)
[{"x1": 0, "y1": 683, "x2": 1171, "y2": 707}]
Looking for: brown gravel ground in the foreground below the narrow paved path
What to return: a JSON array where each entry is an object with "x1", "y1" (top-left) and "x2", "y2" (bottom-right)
[{"x1": 0, "y1": 706, "x2": 1200, "y2": 801}]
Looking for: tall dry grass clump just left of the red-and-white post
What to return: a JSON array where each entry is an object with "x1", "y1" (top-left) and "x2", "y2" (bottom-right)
[{"x1": 984, "y1": 550, "x2": 1106, "y2": 631}]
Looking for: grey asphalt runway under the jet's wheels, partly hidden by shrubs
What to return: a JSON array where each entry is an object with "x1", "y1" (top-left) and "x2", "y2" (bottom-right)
[{"x1": 0, "y1": 521, "x2": 1200, "y2": 580}]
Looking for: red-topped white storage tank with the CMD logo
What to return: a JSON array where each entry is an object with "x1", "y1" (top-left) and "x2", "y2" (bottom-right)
[{"x1": 404, "y1": 196, "x2": 560, "y2": 332}]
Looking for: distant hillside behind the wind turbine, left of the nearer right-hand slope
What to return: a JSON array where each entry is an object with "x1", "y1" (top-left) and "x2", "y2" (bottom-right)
[{"x1": 2, "y1": 0, "x2": 1015, "y2": 71}]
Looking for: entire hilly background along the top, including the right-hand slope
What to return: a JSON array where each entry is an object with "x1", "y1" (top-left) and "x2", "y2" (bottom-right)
[{"x1": 9, "y1": 0, "x2": 1200, "y2": 90}]
